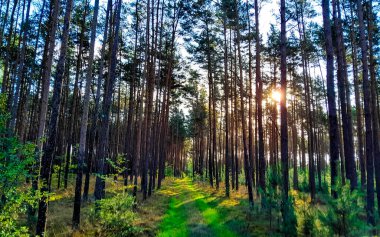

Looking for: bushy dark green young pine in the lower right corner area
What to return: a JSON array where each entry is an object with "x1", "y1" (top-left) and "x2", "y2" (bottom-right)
[{"x1": 319, "y1": 182, "x2": 369, "y2": 236}]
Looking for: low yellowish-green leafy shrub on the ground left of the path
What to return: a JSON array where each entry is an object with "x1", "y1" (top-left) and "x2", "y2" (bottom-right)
[{"x1": 93, "y1": 194, "x2": 139, "y2": 236}]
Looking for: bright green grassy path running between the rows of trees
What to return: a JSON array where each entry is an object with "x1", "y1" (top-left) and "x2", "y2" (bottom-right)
[{"x1": 158, "y1": 178, "x2": 239, "y2": 237}]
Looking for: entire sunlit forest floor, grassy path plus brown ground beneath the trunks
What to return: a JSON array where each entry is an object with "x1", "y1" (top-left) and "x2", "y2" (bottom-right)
[{"x1": 47, "y1": 177, "x2": 279, "y2": 237}]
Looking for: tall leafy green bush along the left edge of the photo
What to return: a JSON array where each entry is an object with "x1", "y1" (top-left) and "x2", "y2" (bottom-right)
[{"x1": 0, "y1": 95, "x2": 38, "y2": 236}]
